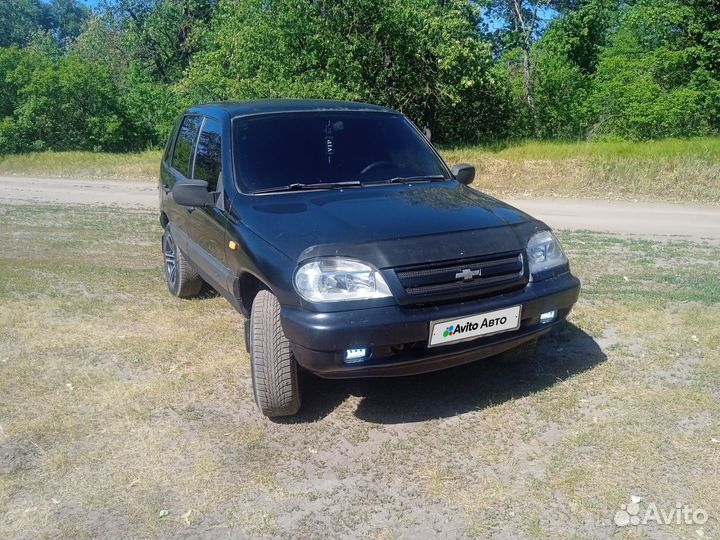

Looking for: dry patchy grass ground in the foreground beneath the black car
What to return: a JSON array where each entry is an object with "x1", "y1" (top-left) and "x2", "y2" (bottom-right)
[{"x1": 0, "y1": 206, "x2": 720, "y2": 539}]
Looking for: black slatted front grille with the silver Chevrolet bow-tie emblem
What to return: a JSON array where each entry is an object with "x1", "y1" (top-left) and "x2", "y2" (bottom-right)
[{"x1": 395, "y1": 252, "x2": 527, "y2": 303}]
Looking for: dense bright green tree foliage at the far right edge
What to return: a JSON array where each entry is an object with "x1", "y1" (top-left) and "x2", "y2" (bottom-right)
[{"x1": 590, "y1": 0, "x2": 720, "y2": 140}]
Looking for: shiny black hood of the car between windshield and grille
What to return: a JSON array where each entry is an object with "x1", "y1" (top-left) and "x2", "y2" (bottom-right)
[{"x1": 237, "y1": 181, "x2": 537, "y2": 267}]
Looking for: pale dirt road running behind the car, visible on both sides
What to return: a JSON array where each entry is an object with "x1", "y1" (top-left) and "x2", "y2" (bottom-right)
[{"x1": 0, "y1": 176, "x2": 720, "y2": 245}]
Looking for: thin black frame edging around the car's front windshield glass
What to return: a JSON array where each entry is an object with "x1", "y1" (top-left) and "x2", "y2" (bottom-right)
[{"x1": 230, "y1": 107, "x2": 455, "y2": 196}]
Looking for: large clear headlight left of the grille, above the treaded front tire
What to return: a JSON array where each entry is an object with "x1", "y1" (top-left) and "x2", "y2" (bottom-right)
[{"x1": 294, "y1": 257, "x2": 392, "y2": 302}]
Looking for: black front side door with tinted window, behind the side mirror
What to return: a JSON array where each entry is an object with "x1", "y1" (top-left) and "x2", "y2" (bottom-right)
[{"x1": 185, "y1": 116, "x2": 232, "y2": 289}]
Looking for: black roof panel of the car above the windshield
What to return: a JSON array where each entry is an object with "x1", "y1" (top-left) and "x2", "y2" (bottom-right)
[{"x1": 187, "y1": 99, "x2": 397, "y2": 118}]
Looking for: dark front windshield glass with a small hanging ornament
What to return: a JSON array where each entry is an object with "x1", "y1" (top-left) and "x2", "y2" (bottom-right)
[{"x1": 233, "y1": 111, "x2": 449, "y2": 192}]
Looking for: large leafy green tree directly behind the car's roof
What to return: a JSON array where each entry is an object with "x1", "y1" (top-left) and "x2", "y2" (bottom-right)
[{"x1": 181, "y1": 0, "x2": 504, "y2": 140}]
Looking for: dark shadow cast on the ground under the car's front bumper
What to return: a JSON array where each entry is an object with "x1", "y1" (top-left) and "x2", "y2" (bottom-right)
[{"x1": 283, "y1": 321, "x2": 607, "y2": 424}]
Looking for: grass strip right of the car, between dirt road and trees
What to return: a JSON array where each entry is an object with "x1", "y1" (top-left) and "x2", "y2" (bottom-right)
[{"x1": 442, "y1": 138, "x2": 720, "y2": 204}]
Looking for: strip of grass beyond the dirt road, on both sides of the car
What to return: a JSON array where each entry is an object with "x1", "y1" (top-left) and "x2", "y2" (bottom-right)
[{"x1": 0, "y1": 138, "x2": 720, "y2": 204}]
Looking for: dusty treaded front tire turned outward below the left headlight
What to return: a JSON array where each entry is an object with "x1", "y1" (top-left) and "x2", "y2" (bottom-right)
[{"x1": 250, "y1": 291, "x2": 300, "y2": 418}]
